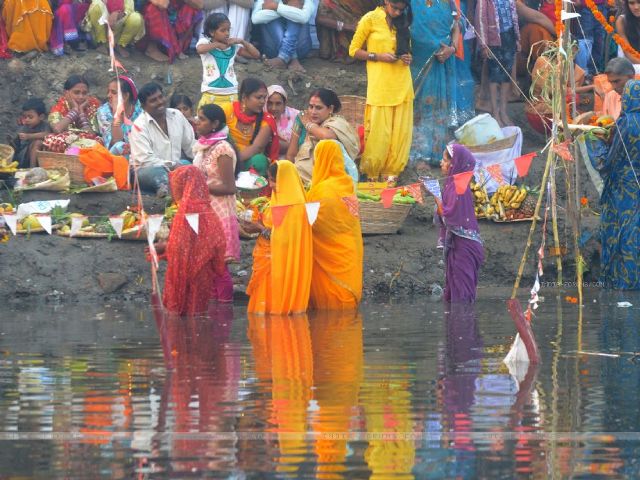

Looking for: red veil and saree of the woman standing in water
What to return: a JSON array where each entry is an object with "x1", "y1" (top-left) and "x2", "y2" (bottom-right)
[{"x1": 163, "y1": 165, "x2": 226, "y2": 315}]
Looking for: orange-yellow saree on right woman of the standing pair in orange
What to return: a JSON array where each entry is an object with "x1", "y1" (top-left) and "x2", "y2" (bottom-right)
[{"x1": 307, "y1": 140, "x2": 363, "y2": 310}]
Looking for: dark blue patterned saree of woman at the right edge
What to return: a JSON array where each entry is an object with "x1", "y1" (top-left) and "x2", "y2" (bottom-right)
[{"x1": 600, "y1": 80, "x2": 640, "y2": 290}]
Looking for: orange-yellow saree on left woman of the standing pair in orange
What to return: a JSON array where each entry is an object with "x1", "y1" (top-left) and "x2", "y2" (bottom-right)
[{"x1": 270, "y1": 160, "x2": 313, "y2": 315}]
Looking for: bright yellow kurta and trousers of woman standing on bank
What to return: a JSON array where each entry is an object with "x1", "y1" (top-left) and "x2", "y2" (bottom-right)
[{"x1": 349, "y1": 7, "x2": 414, "y2": 179}]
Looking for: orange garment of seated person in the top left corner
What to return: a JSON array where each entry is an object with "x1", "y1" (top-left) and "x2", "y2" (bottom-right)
[{"x1": 2, "y1": 0, "x2": 53, "y2": 52}]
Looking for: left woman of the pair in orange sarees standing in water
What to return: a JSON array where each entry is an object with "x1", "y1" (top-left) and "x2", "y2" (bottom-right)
[{"x1": 247, "y1": 160, "x2": 313, "y2": 315}]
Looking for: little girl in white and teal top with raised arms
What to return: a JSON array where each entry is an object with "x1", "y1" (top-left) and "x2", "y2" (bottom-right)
[{"x1": 196, "y1": 13, "x2": 260, "y2": 110}]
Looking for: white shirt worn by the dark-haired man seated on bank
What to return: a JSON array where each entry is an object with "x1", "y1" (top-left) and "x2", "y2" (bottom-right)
[{"x1": 129, "y1": 108, "x2": 195, "y2": 168}]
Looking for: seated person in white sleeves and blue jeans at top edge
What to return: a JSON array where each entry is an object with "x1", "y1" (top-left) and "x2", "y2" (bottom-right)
[{"x1": 251, "y1": 0, "x2": 317, "y2": 72}]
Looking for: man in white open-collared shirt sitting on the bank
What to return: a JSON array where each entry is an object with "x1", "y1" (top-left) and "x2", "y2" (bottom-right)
[{"x1": 129, "y1": 82, "x2": 195, "y2": 197}]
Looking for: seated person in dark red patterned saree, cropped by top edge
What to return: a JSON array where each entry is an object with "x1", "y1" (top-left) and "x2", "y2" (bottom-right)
[{"x1": 142, "y1": 0, "x2": 203, "y2": 63}]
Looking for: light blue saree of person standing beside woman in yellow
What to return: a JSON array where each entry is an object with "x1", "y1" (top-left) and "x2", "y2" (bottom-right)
[{"x1": 410, "y1": 0, "x2": 475, "y2": 165}]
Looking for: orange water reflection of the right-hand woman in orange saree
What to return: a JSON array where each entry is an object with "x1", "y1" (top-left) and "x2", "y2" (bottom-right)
[{"x1": 309, "y1": 310, "x2": 364, "y2": 479}]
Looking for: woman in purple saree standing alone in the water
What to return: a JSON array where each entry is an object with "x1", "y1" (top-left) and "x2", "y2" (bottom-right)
[{"x1": 436, "y1": 145, "x2": 484, "y2": 302}]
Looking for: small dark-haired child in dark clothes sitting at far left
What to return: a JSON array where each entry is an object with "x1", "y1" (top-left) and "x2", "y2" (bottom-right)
[{"x1": 12, "y1": 98, "x2": 51, "y2": 168}]
